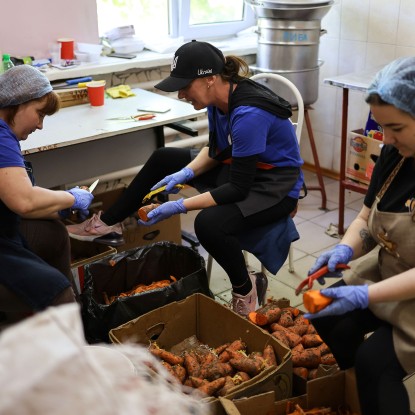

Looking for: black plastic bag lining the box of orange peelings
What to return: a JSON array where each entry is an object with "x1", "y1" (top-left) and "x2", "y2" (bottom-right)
[{"x1": 81, "y1": 242, "x2": 214, "y2": 344}]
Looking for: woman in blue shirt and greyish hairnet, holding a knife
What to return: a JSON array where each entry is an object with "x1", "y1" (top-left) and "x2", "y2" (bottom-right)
[{"x1": 0, "y1": 65, "x2": 93, "y2": 322}]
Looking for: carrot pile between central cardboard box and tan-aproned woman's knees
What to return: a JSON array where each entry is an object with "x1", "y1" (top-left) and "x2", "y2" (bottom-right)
[{"x1": 248, "y1": 300, "x2": 337, "y2": 380}]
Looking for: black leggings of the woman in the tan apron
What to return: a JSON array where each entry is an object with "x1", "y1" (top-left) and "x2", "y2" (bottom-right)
[{"x1": 313, "y1": 281, "x2": 409, "y2": 415}]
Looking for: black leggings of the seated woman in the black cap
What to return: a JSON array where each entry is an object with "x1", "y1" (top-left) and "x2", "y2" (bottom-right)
[{"x1": 101, "y1": 147, "x2": 297, "y2": 286}]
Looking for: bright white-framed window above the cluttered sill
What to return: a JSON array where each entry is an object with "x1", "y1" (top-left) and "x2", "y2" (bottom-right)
[{"x1": 96, "y1": 0, "x2": 256, "y2": 40}]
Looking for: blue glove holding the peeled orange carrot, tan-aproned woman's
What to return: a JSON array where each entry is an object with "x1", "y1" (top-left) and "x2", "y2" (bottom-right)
[{"x1": 304, "y1": 285, "x2": 369, "y2": 319}]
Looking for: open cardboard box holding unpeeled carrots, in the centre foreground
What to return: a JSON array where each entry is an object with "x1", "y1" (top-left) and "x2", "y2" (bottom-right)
[{"x1": 109, "y1": 294, "x2": 292, "y2": 400}]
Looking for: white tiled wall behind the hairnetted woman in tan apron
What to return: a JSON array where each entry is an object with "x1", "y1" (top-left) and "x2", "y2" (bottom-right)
[{"x1": 301, "y1": 0, "x2": 415, "y2": 172}]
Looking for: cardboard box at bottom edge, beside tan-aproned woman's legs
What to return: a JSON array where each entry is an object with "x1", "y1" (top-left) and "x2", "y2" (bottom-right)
[{"x1": 219, "y1": 370, "x2": 360, "y2": 415}]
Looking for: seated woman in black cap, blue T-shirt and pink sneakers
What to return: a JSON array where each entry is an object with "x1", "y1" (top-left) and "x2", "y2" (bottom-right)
[{"x1": 68, "y1": 41, "x2": 303, "y2": 315}]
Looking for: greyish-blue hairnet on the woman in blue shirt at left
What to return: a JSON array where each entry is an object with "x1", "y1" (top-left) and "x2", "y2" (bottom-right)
[{"x1": 0, "y1": 65, "x2": 52, "y2": 108}]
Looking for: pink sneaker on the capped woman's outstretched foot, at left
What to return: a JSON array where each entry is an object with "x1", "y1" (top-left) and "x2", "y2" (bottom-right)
[{"x1": 66, "y1": 211, "x2": 125, "y2": 246}]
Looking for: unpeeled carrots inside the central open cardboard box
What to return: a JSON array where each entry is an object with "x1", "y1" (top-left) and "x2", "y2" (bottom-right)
[{"x1": 149, "y1": 339, "x2": 277, "y2": 397}]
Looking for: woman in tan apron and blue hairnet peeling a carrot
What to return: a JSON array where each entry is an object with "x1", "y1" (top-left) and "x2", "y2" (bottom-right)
[{"x1": 307, "y1": 57, "x2": 415, "y2": 415}]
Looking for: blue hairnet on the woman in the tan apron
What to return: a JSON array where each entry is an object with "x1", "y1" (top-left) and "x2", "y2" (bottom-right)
[{"x1": 367, "y1": 56, "x2": 415, "y2": 117}]
